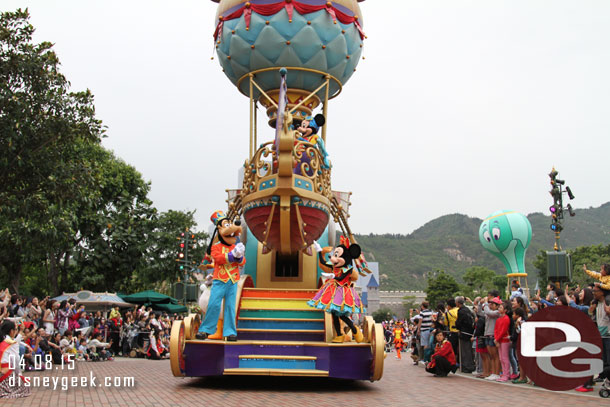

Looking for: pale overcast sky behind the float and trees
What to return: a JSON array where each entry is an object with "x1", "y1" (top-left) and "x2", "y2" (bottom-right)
[{"x1": 0, "y1": 0, "x2": 610, "y2": 233}]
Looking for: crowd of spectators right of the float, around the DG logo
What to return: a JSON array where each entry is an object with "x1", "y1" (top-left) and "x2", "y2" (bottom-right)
[{"x1": 394, "y1": 264, "x2": 610, "y2": 392}]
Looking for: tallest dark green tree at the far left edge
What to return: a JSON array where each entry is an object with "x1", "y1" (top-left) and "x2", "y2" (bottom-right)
[{"x1": 0, "y1": 10, "x2": 104, "y2": 292}]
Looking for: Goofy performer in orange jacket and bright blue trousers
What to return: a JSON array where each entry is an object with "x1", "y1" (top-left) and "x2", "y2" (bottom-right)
[{"x1": 196, "y1": 211, "x2": 246, "y2": 341}]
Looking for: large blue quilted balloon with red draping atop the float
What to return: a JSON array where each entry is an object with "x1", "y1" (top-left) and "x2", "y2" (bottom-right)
[{"x1": 214, "y1": 0, "x2": 364, "y2": 108}]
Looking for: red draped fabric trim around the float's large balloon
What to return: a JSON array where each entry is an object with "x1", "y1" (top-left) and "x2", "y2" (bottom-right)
[{"x1": 214, "y1": 0, "x2": 365, "y2": 41}]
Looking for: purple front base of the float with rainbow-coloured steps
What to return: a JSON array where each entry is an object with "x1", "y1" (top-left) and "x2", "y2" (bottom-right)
[{"x1": 170, "y1": 287, "x2": 383, "y2": 380}]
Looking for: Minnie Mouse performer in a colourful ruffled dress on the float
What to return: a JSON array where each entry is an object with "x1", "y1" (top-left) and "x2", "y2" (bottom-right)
[{"x1": 307, "y1": 236, "x2": 366, "y2": 343}]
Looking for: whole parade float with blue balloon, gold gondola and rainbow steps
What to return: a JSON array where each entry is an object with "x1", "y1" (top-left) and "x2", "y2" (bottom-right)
[{"x1": 170, "y1": 0, "x2": 384, "y2": 381}]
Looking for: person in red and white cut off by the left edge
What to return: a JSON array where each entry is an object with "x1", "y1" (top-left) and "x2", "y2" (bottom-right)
[{"x1": 0, "y1": 320, "x2": 30, "y2": 399}]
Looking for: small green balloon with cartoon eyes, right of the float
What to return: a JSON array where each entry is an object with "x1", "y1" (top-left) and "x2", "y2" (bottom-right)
[{"x1": 479, "y1": 211, "x2": 532, "y2": 274}]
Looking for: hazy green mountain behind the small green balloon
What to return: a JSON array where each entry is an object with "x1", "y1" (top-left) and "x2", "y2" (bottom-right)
[{"x1": 355, "y1": 202, "x2": 610, "y2": 290}]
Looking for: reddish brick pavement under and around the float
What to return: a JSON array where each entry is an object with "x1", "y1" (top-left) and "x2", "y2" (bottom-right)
[{"x1": 0, "y1": 353, "x2": 605, "y2": 407}]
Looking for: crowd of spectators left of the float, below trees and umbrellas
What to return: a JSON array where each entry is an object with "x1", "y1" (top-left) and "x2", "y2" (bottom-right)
[{"x1": 0, "y1": 288, "x2": 180, "y2": 371}]
